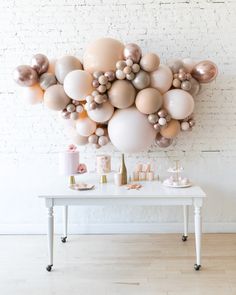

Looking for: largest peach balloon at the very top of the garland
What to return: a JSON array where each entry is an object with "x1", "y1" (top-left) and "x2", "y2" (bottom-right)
[{"x1": 83, "y1": 38, "x2": 124, "y2": 73}]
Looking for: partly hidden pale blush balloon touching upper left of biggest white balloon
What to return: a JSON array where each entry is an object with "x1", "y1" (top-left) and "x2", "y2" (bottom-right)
[{"x1": 88, "y1": 101, "x2": 114, "y2": 123}]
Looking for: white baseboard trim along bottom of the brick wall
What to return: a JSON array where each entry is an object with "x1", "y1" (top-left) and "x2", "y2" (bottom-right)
[{"x1": 0, "y1": 223, "x2": 236, "y2": 234}]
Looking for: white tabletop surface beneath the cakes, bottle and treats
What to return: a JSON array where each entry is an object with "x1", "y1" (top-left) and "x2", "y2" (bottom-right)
[{"x1": 39, "y1": 178, "x2": 206, "y2": 198}]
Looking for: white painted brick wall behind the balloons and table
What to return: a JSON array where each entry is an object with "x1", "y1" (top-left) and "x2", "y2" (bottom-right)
[{"x1": 0, "y1": 0, "x2": 236, "y2": 233}]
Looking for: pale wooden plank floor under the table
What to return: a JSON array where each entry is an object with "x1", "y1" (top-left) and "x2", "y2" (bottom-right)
[{"x1": 0, "y1": 234, "x2": 236, "y2": 295}]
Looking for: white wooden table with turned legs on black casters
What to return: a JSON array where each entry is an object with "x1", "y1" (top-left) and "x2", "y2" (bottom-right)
[{"x1": 39, "y1": 181, "x2": 206, "y2": 271}]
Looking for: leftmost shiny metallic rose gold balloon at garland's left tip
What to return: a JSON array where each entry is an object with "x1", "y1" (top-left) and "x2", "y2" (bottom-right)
[{"x1": 13, "y1": 65, "x2": 38, "y2": 87}]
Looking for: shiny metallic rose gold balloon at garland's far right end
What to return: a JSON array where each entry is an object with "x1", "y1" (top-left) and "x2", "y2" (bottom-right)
[{"x1": 191, "y1": 60, "x2": 218, "y2": 83}]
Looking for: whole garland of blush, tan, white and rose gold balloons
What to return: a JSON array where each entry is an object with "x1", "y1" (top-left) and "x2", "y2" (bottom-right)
[{"x1": 14, "y1": 38, "x2": 218, "y2": 153}]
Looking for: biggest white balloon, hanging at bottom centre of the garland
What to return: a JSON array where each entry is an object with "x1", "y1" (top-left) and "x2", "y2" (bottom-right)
[{"x1": 108, "y1": 107, "x2": 156, "y2": 153}]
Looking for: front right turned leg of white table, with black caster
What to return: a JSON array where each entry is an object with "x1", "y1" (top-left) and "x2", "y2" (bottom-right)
[{"x1": 194, "y1": 204, "x2": 202, "y2": 270}]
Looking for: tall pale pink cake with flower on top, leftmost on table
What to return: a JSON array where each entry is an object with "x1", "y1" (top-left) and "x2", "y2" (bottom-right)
[{"x1": 59, "y1": 145, "x2": 79, "y2": 175}]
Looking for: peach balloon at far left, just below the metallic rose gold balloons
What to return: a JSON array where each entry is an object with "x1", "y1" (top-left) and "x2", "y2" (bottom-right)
[{"x1": 19, "y1": 84, "x2": 43, "y2": 105}]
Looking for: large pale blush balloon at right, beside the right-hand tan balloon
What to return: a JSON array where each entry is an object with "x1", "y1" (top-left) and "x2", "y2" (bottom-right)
[{"x1": 163, "y1": 89, "x2": 194, "y2": 120}]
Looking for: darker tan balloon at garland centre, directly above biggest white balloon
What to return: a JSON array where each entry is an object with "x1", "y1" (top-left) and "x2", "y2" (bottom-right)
[{"x1": 108, "y1": 80, "x2": 136, "y2": 109}]
